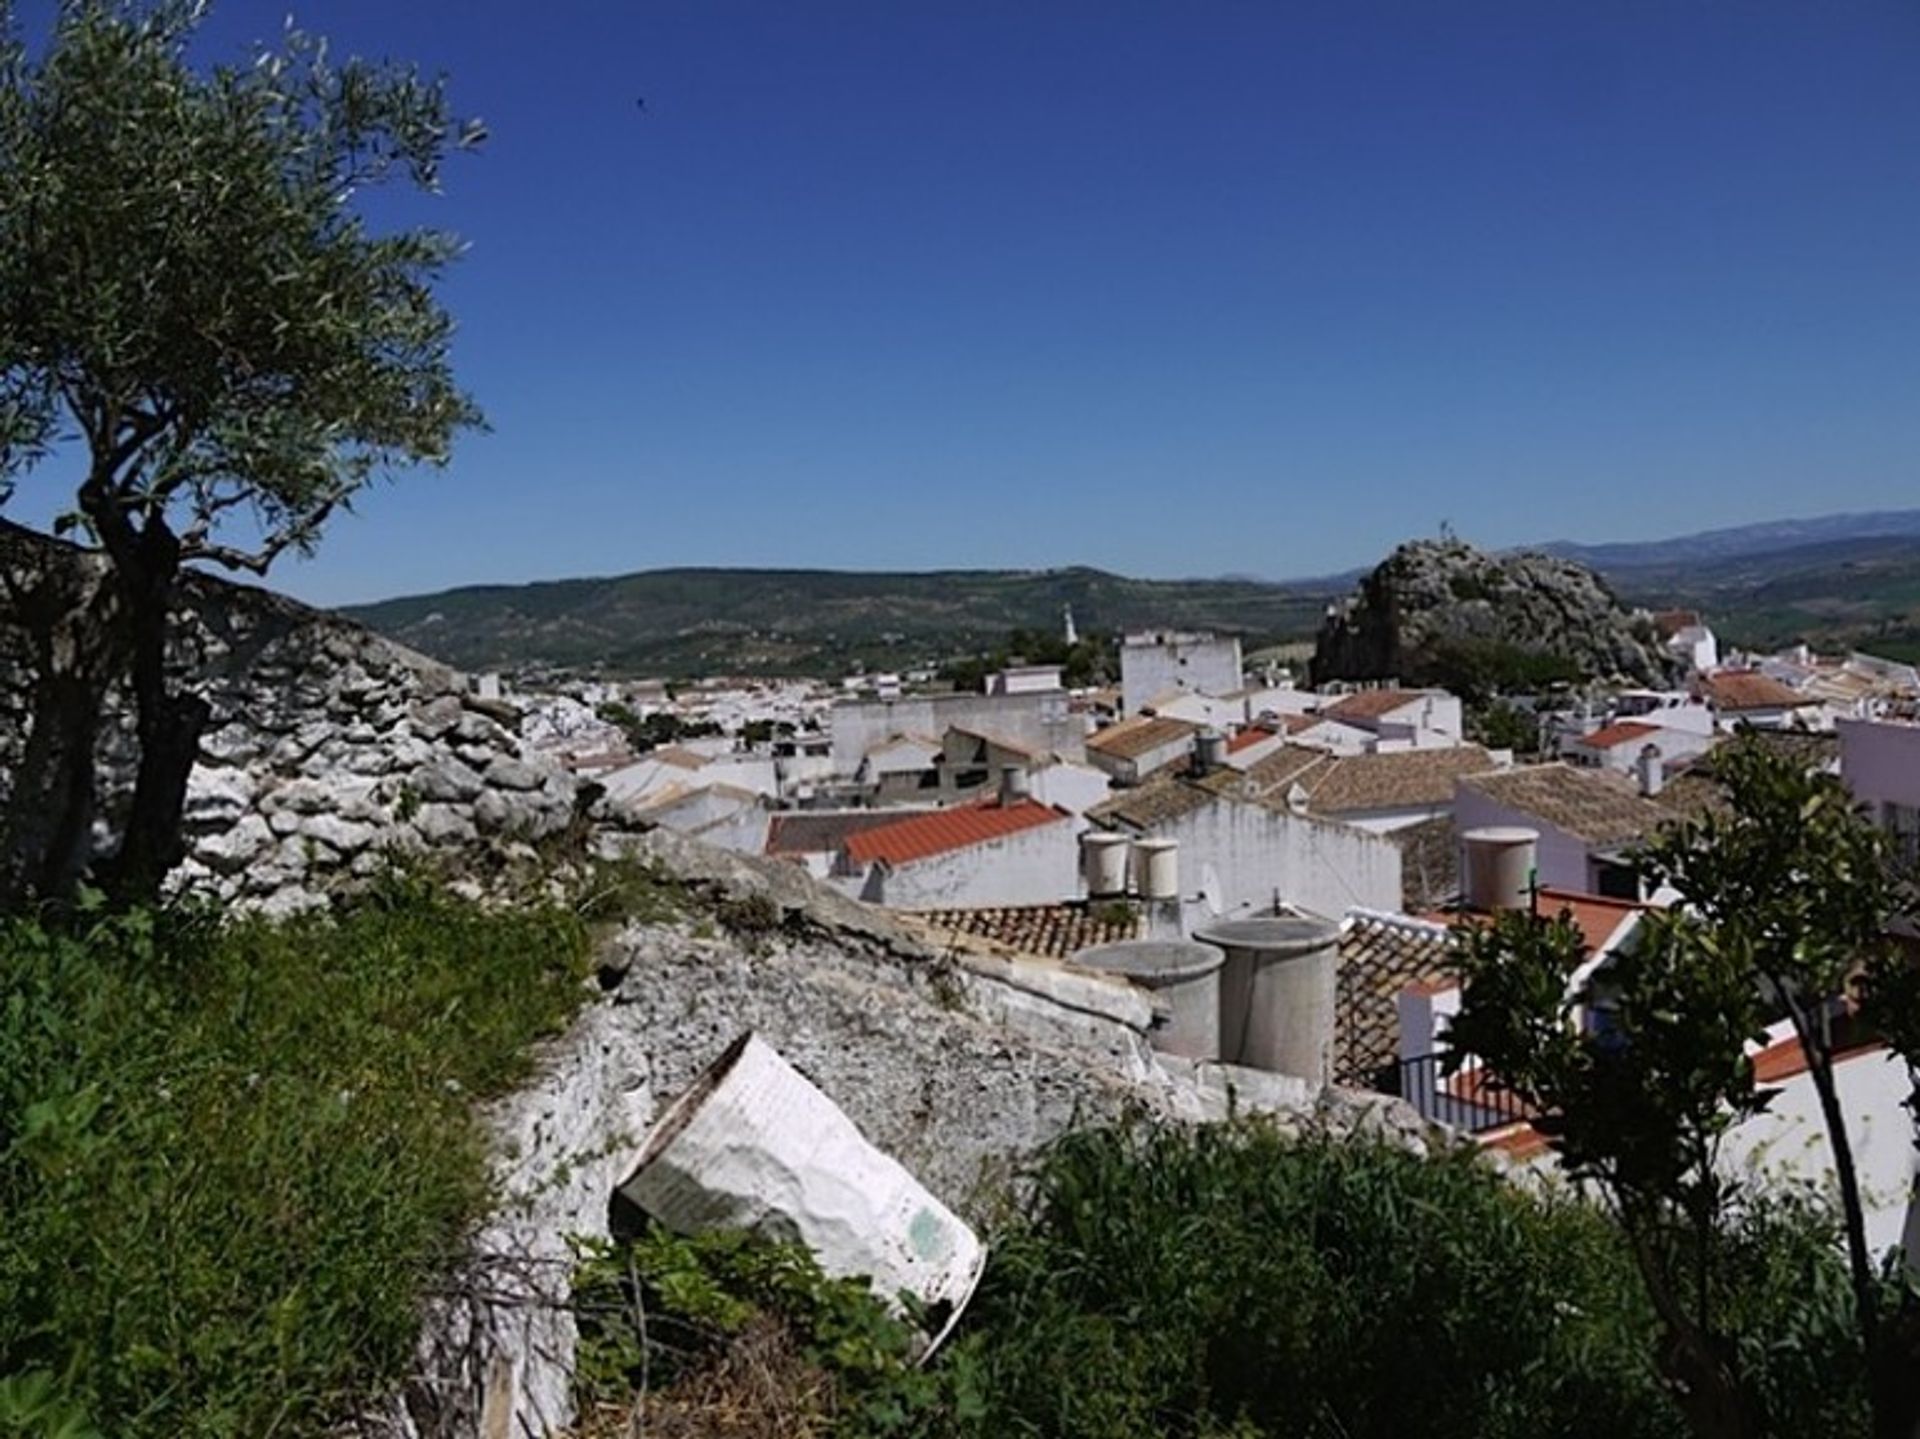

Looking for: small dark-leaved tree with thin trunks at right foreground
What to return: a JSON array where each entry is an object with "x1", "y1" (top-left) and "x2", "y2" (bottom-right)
[{"x1": 1448, "y1": 740, "x2": 1920, "y2": 1439}]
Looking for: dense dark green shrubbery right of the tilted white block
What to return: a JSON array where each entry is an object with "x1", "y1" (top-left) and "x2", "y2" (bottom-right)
[{"x1": 943, "y1": 1122, "x2": 1678, "y2": 1439}]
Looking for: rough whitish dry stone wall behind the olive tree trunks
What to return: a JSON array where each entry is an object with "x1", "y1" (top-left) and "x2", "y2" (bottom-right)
[{"x1": 0, "y1": 530, "x2": 578, "y2": 913}]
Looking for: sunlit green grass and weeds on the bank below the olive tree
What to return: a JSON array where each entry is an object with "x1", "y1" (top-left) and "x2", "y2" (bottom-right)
[{"x1": 0, "y1": 882, "x2": 588, "y2": 1439}]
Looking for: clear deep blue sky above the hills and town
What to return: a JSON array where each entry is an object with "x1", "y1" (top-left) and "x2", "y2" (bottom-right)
[{"x1": 11, "y1": 0, "x2": 1920, "y2": 601}]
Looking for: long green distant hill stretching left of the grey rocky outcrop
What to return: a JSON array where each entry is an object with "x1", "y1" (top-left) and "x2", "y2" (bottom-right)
[{"x1": 344, "y1": 569, "x2": 1340, "y2": 676}]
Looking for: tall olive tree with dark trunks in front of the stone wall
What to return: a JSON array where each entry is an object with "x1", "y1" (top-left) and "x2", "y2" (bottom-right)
[{"x1": 0, "y1": 0, "x2": 480, "y2": 903}]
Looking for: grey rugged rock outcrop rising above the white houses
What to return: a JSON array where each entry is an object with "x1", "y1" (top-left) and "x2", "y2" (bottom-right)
[{"x1": 1313, "y1": 540, "x2": 1668, "y2": 695}]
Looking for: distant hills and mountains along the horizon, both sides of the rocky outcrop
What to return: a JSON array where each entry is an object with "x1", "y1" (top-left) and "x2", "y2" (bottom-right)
[{"x1": 344, "y1": 509, "x2": 1920, "y2": 678}]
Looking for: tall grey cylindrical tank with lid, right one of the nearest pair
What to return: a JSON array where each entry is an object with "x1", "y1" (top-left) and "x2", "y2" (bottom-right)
[{"x1": 1194, "y1": 918, "x2": 1340, "y2": 1084}]
